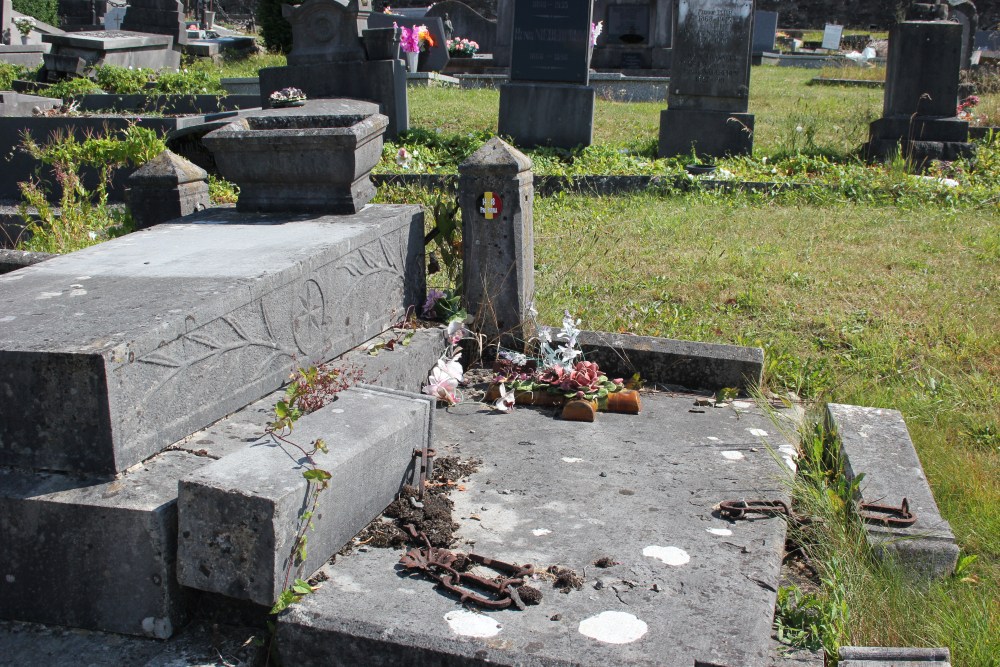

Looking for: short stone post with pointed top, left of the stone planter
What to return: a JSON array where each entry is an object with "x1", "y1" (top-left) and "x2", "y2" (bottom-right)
[{"x1": 125, "y1": 150, "x2": 210, "y2": 229}]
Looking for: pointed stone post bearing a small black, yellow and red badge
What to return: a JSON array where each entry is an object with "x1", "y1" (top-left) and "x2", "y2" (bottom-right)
[{"x1": 458, "y1": 137, "x2": 535, "y2": 351}]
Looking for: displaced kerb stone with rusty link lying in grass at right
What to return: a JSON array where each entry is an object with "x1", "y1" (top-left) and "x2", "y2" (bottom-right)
[{"x1": 826, "y1": 403, "x2": 959, "y2": 577}]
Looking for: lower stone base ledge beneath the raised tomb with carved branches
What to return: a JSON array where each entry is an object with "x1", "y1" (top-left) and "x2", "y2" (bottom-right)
[{"x1": 0, "y1": 327, "x2": 443, "y2": 640}]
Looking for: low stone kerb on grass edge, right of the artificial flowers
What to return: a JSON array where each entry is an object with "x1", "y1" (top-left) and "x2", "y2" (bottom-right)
[{"x1": 579, "y1": 331, "x2": 764, "y2": 395}]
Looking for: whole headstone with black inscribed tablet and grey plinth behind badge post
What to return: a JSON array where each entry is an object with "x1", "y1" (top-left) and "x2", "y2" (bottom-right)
[{"x1": 498, "y1": 0, "x2": 596, "y2": 148}]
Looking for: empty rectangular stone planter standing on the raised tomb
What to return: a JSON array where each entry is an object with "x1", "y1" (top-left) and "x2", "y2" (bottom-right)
[{"x1": 204, "y1": 99, "x2": 389, "y2": 213}]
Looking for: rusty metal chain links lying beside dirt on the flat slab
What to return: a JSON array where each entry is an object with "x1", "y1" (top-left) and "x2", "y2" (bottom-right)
[{"x1": 399, "y1": 524, "x2": 535, "y2": 609}]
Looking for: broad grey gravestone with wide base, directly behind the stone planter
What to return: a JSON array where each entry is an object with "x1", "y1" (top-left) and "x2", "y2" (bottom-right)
[{"x1": 260, "y1": 0, "x2": 410, "y2": 139}]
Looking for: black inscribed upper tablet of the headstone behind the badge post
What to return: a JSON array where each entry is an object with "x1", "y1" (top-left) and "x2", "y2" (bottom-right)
[{"x1": 510, "y1": 0, "x2": 593, "y2": 85}]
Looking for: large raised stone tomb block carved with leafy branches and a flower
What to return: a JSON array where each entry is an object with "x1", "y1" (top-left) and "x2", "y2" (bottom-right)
[{"x1": 0, "y1": 205, "x2": 424, "y2": 474}]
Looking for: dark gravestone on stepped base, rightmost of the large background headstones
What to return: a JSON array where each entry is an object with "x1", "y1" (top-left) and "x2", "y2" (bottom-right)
[{"x1": 865, "y1": 21, "x2": 973, "y2": 170}]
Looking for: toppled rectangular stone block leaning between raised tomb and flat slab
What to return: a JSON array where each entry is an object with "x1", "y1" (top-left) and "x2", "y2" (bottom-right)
[{"x1": 177, "y1": 387, "x2": 434, "y2": 606}]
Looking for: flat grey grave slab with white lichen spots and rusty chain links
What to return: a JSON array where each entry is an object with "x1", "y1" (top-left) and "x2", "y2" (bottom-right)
[{"x1": 278, "y1": 394, "x2": 792, "y2": 667}]
